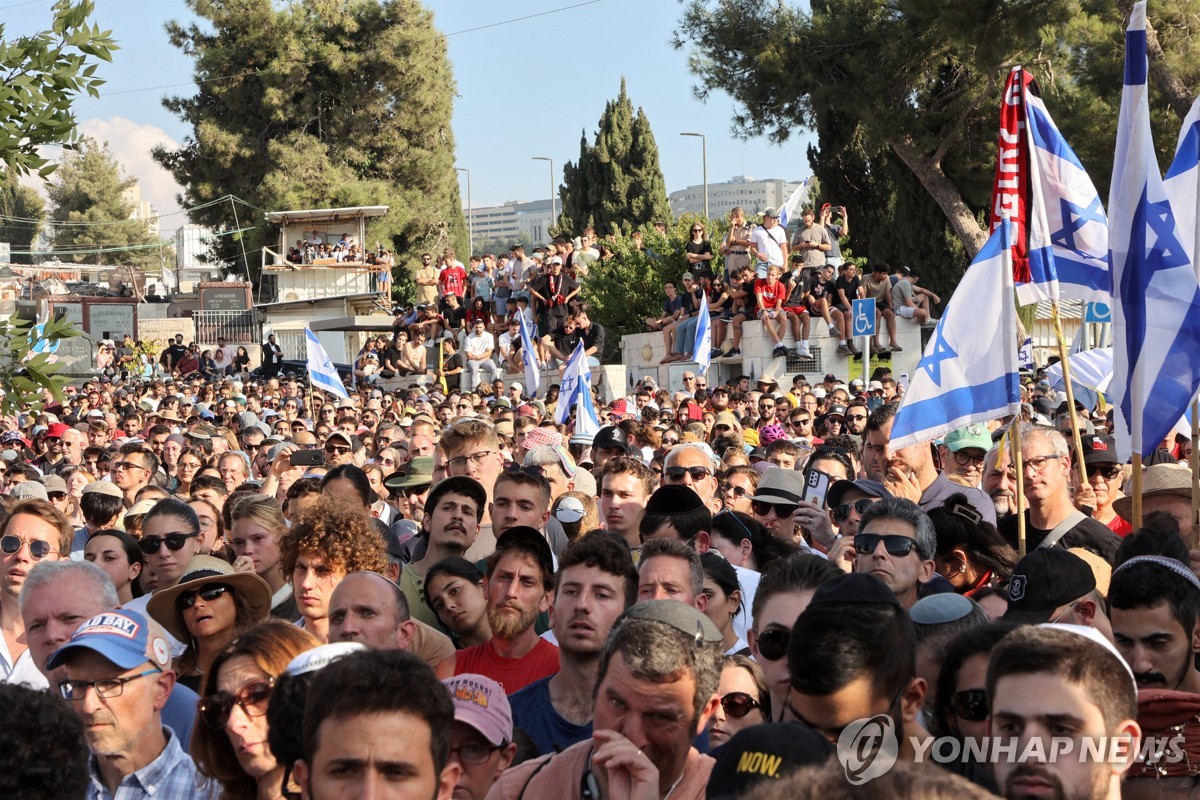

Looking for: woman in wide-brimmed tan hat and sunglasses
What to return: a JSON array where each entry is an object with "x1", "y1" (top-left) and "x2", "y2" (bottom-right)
[{"x1": 146, "y1": 555, "x2": 271, "y2": 692}]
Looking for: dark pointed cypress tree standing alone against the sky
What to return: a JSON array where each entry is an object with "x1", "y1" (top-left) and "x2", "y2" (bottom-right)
[{"x1": 558, "y1": 78, "x2": 671, "y2": 236}]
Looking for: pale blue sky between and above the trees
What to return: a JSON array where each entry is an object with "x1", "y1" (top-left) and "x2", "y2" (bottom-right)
[{"x1": 0, "y1": 0, "x2": 814, "y2": 234}]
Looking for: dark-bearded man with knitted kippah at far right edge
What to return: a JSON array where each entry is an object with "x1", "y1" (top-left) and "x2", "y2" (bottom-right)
[{"x1": 1109, "y1": 555, "x2": 1200, "y2": 694}]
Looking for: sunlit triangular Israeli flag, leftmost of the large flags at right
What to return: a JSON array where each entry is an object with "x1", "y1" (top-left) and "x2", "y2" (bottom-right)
[{"x1": 890, "y1": 222, "x2": 1021, "y2": 450}]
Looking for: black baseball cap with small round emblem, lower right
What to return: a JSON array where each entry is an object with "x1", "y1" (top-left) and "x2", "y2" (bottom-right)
[{"x1": 1003, "y1": 547, "x2": 1096, "y2": 625}]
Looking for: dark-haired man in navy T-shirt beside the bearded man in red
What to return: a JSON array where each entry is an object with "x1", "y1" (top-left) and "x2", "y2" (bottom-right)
[{"x1": 509, "y1": 534, "x2": 637, "y2": 756}]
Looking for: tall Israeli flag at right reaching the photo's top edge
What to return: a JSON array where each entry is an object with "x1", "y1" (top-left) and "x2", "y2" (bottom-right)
[{"x1": 1109, "y1": 0, "x2": 1200, "y2": 459}]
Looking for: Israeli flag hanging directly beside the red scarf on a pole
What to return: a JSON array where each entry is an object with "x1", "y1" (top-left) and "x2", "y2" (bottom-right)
[{"x1": 1016, "y1": 92, "x2": 1112, "y2": 305}]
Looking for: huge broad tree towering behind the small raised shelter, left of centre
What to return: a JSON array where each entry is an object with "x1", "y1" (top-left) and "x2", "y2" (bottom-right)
[{"x1": 155, "y1": 0, "x2": 468, "y2": 273}]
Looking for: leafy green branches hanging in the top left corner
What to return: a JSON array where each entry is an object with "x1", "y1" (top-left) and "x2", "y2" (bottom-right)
[{"x1": 0, "y1": 0, "x2": 118, "y2": 178}]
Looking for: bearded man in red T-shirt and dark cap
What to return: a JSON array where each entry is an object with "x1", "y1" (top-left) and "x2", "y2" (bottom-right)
[{"x1": 455, "y1": 525, "x2": 558, "y2": 694}]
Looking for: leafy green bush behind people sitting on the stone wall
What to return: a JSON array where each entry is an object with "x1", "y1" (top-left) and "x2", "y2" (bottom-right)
[{"x1": 582, "y1": 215, "x2": 728, "y2": 363}]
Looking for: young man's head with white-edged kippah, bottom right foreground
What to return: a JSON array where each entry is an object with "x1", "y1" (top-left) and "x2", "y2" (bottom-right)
[{"x1": 988, "y1": 625, "x2": 1141, "y2": 800}]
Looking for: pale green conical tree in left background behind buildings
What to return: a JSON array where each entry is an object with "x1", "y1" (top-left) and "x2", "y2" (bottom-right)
[{"x1": 46, "y1": 139, "x2": 163, "y2": 269}]
